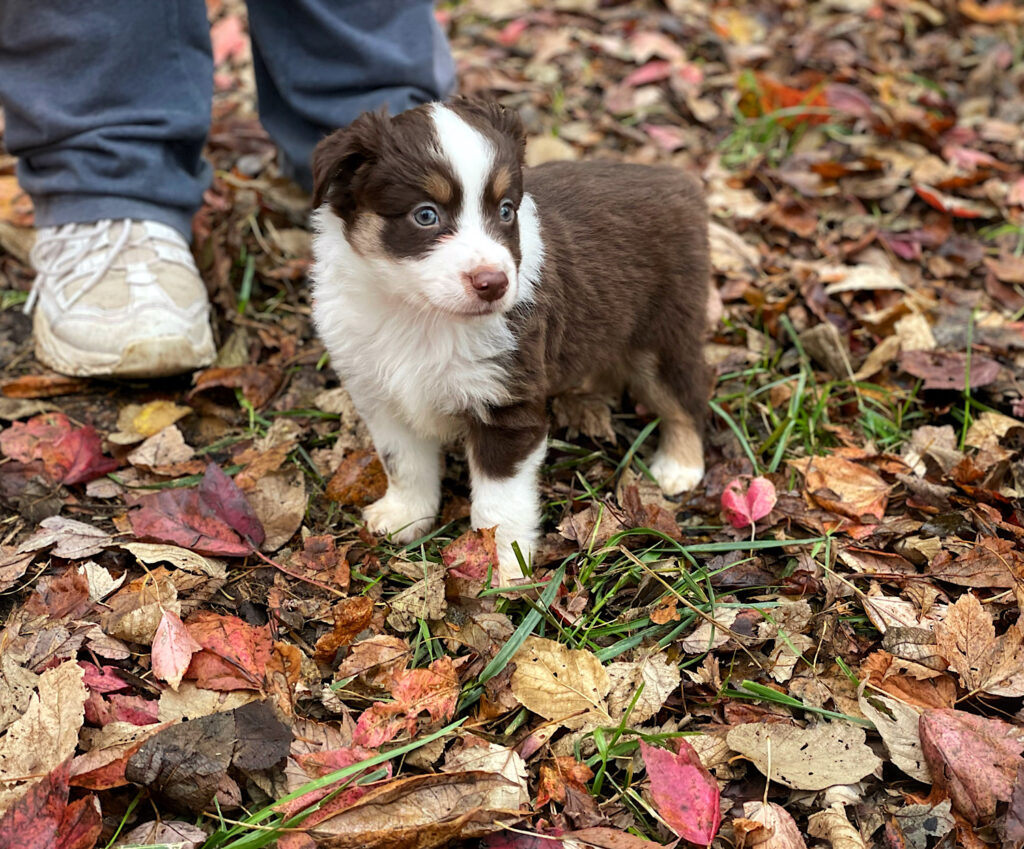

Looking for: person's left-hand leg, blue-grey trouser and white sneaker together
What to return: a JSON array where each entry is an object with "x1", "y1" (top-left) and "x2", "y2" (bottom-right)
[{"x1": 0, "y1": 0, "x2": 215, "y2": 377}]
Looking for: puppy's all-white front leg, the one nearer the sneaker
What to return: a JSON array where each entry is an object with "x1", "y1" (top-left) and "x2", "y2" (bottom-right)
[{"x1": 356, "y1": 401, "x2": 441, "y2": 544}]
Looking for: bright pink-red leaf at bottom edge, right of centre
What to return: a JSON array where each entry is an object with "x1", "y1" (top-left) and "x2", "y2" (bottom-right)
[{"x1": 640, "y1": 739, "x2": 722, "y2": 846}]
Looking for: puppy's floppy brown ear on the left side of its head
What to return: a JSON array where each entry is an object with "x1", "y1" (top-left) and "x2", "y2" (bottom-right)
[{"x1": 312, "y1": 112, "x2": 389, "y2": 213}]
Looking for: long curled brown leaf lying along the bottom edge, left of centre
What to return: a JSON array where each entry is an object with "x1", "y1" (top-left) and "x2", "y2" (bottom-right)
[{"x1": 310, "y1": 771, "x2": 520, "y2": 849}]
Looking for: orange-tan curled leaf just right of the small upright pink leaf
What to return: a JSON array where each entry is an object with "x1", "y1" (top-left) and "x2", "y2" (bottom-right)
[{"x1": 790, "y1": 455, "x2": 892, "y2": 522}]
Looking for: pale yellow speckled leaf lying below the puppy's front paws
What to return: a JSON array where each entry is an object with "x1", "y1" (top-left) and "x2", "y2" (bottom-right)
[{"x1": 512, "y1": 637, "x2": 612, "y2": 729}]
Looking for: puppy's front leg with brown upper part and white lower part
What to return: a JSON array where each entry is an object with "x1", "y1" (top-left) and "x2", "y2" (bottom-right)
[{"x1": 467, "y1": 405, "x2": 548, "y2": 585}]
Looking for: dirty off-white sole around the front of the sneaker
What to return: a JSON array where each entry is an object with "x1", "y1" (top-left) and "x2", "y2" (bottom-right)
[{"x1": 33, "y1": 309, "x2": 217, "y2": 378}]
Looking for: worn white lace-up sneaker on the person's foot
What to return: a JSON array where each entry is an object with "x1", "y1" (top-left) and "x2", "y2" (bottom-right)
[{"x1": 25, "y1": 218, "x2": 216, "y2": 377}]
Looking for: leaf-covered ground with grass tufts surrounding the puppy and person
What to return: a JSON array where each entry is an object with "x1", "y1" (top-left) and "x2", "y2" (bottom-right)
[{"x1": 0, "y1": 0, "x2": 1024, "y2": 849}]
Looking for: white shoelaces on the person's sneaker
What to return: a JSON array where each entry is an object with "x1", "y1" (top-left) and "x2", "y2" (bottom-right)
[{"x1": 25, "y1": 218, "x2": 132, "y2": 312}]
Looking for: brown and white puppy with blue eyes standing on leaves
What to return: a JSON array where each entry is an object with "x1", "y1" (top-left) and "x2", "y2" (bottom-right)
[{"x1": 312, "y1": 99, "x2": 709, "y2": 583}]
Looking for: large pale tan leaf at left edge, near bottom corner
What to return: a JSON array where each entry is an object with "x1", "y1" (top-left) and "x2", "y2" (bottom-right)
[{"x1": 0, "y1": 661, "x2": 88, "y2": 816}]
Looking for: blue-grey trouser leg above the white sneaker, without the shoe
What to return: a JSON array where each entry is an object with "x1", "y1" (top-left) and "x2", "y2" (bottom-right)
[{"x1": 0, "y1": 0, "x2": 212, "y2": 238}]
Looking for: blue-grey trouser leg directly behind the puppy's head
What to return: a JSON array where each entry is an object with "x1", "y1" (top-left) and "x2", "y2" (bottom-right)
[{"x1": 249, "y1": 0, "x2": 455, "y2": 190}]
